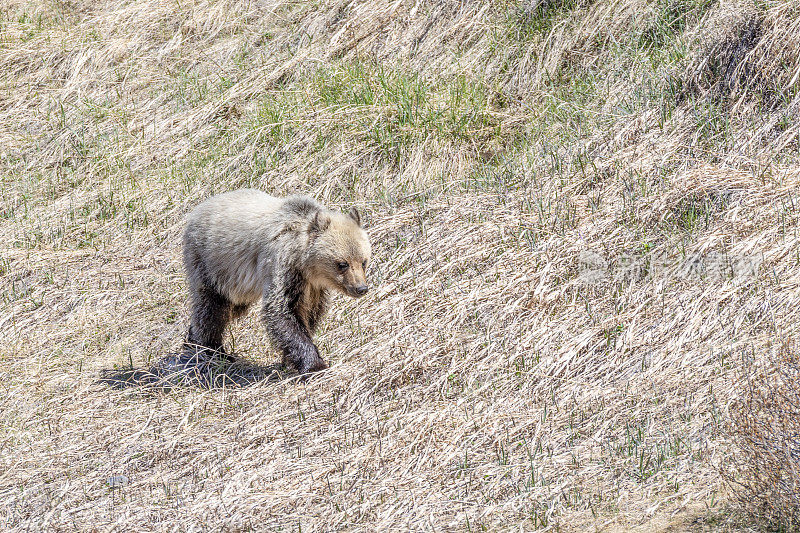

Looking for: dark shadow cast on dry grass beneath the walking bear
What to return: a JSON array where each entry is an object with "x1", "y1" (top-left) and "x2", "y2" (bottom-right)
[{"x1": 97, "y1": 352, "x2": 300, "y2": 389}]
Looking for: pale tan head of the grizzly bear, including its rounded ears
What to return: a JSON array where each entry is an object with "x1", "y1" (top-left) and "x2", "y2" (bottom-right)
[{"x1": 306, "y1": 209, "x2": 372, "y2": 298}]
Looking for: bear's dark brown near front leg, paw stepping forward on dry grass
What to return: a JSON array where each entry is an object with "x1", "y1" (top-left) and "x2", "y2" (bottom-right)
[{"x1": 264, "y1": 299, "x2": 328, "y2": 374}]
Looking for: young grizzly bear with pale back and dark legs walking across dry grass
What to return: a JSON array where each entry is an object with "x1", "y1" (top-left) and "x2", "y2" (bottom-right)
[{"x1": 183, "y1": 189, "x2": 371, "y2": 374}]
